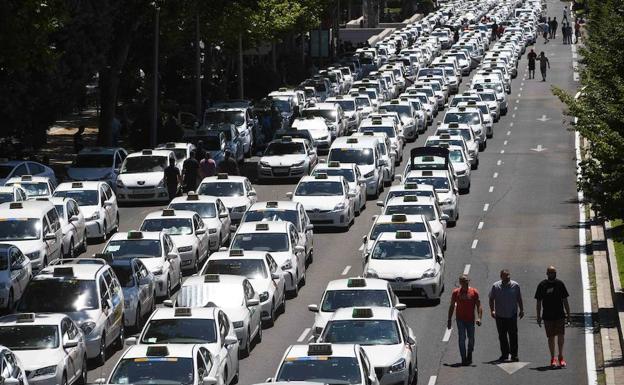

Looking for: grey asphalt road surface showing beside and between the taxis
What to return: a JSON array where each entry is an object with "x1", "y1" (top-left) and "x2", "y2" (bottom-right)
[{"x1": 88, "y1": 1, "x2": 587, "y2": 385}]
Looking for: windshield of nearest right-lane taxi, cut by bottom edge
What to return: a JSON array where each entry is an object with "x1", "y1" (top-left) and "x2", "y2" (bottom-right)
[{"x1": 276, "y1": 356, "x2": 362, "y2": 385}]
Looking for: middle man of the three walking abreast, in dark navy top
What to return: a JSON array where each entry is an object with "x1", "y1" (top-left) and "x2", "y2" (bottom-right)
[{"x1": 488, "y1": 269, "x2": 524, "y2": 362}]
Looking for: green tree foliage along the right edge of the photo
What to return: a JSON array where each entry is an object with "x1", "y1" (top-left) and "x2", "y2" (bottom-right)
[{"x1": 554, "y1": 0, "x2": 624, "y2": 219}]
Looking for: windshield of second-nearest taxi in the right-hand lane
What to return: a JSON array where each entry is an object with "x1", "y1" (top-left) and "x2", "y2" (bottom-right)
[{"x1": 321, "y1": 320, "x2": 401, "y2": 345}]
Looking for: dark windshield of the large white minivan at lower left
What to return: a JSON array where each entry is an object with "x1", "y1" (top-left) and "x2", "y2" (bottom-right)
[{"x1": 17, "y1": 279, "x2": 98, "y2": 313}]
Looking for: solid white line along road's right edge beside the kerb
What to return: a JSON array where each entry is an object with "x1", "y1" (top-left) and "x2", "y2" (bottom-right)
[{"x1": 574, "y1": 131, "x2": 598, "y2": 385}]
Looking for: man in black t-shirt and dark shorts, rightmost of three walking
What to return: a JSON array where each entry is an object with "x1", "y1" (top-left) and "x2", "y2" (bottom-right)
[{"x1": 535, "y1": 266, "x2": 570, "y2": 368}]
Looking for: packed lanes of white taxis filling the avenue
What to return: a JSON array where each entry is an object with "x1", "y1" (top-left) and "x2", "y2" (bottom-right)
[{"x1": 0, "y1": 0, "x2": 541, "y2": 385}]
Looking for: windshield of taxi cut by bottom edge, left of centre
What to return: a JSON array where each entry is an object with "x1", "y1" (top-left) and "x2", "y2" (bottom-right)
[{"x1": 109, "y1": 357, "x2": 194, "y2": 385}]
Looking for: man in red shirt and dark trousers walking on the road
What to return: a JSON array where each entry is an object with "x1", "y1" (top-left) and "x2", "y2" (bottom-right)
[{"x1": 446, "y1": 274, "x2": 483, "y2": 366}]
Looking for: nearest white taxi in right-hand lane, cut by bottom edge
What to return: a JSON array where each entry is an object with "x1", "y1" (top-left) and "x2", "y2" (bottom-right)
[{"x1": 272, "y1": 343, "x2": 379, "y2": 385}]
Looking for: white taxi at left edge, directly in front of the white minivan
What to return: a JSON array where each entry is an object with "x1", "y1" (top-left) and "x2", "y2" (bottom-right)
[{"x1": 0, "y1": 313, "x2": 88, "y2": 385}]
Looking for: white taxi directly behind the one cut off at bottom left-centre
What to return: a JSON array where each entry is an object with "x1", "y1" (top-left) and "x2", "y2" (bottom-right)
[{"x1": 126, "y1": 307, "x2": 239, "y2": 384}]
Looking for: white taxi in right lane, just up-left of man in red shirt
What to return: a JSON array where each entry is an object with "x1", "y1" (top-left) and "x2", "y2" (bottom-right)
[{"x1": 364, "y1": 230, "x2": 445, "y2": 301}]
